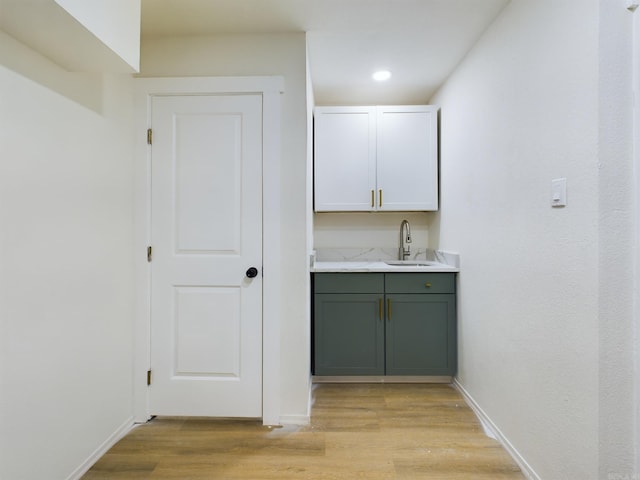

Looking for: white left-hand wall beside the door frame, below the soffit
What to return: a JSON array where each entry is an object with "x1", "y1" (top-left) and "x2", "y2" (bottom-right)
[{"x1": 0, "y1": 37, "x2": 133, "y2": 480}]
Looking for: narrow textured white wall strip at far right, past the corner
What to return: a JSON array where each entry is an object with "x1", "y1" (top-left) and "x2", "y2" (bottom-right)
[{"x1": 598, "y1": 0, "x2": 640, "y2": 479}]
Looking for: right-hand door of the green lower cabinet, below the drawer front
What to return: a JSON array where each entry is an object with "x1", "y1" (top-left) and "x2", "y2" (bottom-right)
[{"x1": 386, "y1": 294, "x2": 457, "y2": 375}]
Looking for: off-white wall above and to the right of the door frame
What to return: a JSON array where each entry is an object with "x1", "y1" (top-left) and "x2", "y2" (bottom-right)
[{"x1": 141, "y1": 34, "x2": 310, "y2": 422}]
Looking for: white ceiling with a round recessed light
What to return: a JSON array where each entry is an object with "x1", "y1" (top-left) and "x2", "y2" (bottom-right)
[{"x1": 142, "y1": 0, "x2": 510, "y2": 105}]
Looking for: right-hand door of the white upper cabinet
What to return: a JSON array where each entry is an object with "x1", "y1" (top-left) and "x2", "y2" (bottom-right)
[{"x1": 376, "y1": 106, "x2": 438, "y2": 211}]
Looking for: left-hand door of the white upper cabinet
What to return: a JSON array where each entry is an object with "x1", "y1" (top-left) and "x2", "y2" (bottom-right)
[{"x1": 314, "y1": 107, "x2": 376, "y2": 212}]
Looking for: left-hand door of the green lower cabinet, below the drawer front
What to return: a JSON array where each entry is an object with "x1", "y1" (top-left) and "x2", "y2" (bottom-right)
[{"x1": 314, "y1": 293, "x2": 385, "y2": 376}]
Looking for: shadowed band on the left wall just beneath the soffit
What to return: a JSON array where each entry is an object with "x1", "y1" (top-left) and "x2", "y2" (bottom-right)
[{"x1": 0, "y1": 31, "x2": 103, "y2": 114}]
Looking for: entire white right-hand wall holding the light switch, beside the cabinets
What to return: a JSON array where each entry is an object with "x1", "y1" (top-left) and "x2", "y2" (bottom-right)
[{"x1": 429, "y1": 0, "x2": 634, "y2": 480}]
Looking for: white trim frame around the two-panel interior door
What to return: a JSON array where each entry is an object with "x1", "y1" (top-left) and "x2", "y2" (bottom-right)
[{"x1": 133, "y1": 76, "x2": 284, "y2": 425}]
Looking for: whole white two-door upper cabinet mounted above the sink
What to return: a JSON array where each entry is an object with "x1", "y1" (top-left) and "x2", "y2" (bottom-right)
[{"x1": 314, "y1": 105, "x2": 438, "y2": 212}]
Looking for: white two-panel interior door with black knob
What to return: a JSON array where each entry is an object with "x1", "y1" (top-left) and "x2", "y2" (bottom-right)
[{"x1": 149, "y1": 94, "x2": 262, "y2": 417}]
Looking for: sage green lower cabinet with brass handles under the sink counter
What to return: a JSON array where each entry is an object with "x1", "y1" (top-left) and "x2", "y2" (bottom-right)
[{"x1": 313, "y1": 272, "x2": 457, "y2": 376}]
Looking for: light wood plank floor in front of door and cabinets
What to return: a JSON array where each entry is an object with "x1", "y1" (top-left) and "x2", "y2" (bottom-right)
[{"x1": 83, "y1": 384, "x2": 525, "y2": 480}]
